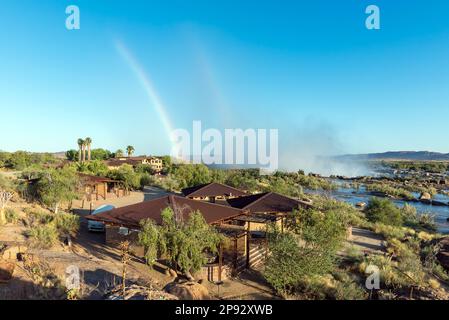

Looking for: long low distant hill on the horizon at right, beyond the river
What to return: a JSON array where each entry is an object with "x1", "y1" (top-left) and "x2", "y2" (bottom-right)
[{"x1": 334, "y1": 151, "x2": 449, "y2": 161}]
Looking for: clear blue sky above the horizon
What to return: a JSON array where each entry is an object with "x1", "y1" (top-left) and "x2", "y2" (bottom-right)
[{"x1": 0, "y1": 0, "x2": 449, "y2": 157}]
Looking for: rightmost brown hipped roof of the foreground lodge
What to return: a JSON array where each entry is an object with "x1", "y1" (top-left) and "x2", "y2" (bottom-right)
[{"x1": 227, "y1": 192, "x2": 310, "y2": 213}]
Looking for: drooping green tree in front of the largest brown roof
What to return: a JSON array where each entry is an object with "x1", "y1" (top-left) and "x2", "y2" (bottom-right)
[{"x1": 139, "y1": 208, "x2": 222, "y2": 275}]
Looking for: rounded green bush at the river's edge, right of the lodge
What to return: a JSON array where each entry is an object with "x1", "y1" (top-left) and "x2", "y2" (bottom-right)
[{"x1": 365, "y1": 198, "x2": 403, "y2": 226}]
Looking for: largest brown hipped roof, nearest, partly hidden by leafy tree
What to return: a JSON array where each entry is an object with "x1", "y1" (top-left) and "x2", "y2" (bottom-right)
[{"x1": 87, "y1": 195, "x2": 245, "y2": 228}]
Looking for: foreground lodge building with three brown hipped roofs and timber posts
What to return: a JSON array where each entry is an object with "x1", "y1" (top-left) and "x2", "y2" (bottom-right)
[{"x1": 87, "y1": 184, "x2": 310, "y2": 281}]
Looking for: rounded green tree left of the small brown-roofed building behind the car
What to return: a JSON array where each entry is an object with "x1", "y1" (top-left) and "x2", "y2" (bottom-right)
[{"x1": 36, "y1": 167, "x2": 79, "y2": 213}]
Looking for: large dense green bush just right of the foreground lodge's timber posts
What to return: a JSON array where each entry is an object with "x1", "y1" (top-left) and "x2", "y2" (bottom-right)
[{"x1": 264, "y1": 210, "x2": 346, "y2": 295}]
